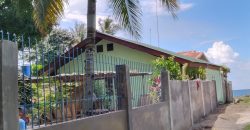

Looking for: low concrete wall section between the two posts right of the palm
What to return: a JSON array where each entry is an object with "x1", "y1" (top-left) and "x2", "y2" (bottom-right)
[{"x1": 132, "y1": 102, "x2": 170, "y2": 130}]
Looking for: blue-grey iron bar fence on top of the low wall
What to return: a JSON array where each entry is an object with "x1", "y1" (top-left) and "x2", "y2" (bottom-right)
[{"x1": 0, "y1": 31, "x2": 160, "y2": 129}]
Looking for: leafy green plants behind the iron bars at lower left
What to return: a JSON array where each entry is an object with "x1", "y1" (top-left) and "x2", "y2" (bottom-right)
[{"x1": 18, "y1": 77, "x2": 73, "y2": 122}]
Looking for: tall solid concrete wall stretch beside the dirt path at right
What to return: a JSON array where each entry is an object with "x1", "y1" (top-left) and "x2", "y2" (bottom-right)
[{"x1": 170, "y1": 81, "x2": 217, "y2": 130}]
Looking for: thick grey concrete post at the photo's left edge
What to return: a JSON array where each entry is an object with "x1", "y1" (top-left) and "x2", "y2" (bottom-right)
[{"x1": 0, "y1": 41, "x2": 18, "y2": 130}]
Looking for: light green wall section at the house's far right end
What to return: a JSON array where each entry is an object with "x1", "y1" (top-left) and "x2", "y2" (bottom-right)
[{"x1": 206, "y1": 69, "x2": 225, "y2": 103}]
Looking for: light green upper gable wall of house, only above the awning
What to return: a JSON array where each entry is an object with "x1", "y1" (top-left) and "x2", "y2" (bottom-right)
[{"x1": 57, "y1": 40, "x2": 156, "y2": 74}]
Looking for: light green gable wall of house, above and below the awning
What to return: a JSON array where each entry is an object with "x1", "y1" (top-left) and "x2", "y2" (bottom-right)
[{"x1": 58, "y1": 40, "x2": 156, "y2": 107}]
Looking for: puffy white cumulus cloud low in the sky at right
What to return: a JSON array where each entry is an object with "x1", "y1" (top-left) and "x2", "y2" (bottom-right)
[{"x1": 206, "y1": 41, "x2": 239, "y2": 65}]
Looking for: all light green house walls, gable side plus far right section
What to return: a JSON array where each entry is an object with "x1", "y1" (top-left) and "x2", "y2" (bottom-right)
[{"x1": 58, "y1": 40, "x2": 225, "y2": 107}]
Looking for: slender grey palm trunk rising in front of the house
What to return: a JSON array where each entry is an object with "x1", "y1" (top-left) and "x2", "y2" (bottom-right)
[{"x1": 84, "y1": 0, "x2": 96, "y2": 113}]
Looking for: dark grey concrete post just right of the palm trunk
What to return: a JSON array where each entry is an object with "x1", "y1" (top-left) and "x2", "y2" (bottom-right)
[{"x1": 116, "y1": 65, "x2": 133, "y2": 130}]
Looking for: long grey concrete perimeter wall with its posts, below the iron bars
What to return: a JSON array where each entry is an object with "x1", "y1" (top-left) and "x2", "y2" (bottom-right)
[{"x1": 30, "y1": 66, "x2": 217, "y2": 130}]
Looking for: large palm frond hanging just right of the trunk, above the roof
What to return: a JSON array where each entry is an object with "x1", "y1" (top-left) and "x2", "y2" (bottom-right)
[{"x1": 109, "y1": 0, "x2": 142, "y2": 39}]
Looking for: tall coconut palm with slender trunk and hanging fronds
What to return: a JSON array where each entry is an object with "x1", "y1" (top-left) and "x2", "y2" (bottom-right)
[{"x1": 33, "y1": 0, "x2": 179, "y2": 112}]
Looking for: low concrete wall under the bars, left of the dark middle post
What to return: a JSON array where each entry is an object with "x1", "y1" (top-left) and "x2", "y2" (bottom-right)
[{"x1": 37, "y1": 111, "x2": 128, "y2": 130}]
